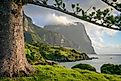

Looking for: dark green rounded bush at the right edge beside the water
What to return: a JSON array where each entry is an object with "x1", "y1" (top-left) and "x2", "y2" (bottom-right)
[{"x1": 101, "y1": 64, "x2": 121, "y2": 75}]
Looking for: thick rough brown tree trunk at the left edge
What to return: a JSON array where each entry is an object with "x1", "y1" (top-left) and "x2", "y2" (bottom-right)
[{"x1": 0, "y1": 0, "x2": 34, "y2": 77}]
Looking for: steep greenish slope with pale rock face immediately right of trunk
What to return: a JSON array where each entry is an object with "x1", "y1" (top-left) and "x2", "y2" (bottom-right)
[{"x1": 24, "y1": 16, "x2": 43, "y2": 43}]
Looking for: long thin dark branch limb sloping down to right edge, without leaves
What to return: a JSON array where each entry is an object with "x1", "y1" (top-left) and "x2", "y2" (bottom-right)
[{"x1": 29, "y1": 1, "x2": 121, "y2": 31}]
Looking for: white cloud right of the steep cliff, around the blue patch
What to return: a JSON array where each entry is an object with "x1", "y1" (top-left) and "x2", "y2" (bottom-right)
[{"x1": 81, "y1": 21, "x2": 121, "y2": 54}]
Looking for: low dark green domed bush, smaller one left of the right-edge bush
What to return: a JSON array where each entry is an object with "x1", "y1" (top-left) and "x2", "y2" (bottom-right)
[{"x1": 72, "y1": 63, "x2": 96, "y2": 72}]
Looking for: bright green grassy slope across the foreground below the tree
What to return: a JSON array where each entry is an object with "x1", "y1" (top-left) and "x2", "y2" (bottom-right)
[{"x1": 0, "y1": 65, "x2": 121, "y2": 81}]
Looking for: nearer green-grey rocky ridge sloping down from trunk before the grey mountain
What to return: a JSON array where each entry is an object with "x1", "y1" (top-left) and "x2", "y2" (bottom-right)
[{"x1": 24, "y1": 16, "x2": 78, "y2": 48}]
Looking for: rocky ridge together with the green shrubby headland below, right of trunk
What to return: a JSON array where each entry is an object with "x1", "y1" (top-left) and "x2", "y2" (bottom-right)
[{"x1": 24, "y1": 16, "x2": 90, "y2": 64}]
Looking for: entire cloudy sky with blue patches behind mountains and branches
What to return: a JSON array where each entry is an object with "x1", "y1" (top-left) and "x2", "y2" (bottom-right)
[{"x1": 24, "y1": 0, "x2": 121, "y2": 54}]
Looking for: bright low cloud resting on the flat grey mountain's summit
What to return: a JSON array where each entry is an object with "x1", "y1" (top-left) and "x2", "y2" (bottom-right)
[{"x1": 32, "y1": 13, "x2": 74, "y2": 26}]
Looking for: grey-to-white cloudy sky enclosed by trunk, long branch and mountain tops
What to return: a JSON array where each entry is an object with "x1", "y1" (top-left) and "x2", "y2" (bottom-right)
[{"x1": 24, "y1": 4, "x2": 74, "y2": 26}]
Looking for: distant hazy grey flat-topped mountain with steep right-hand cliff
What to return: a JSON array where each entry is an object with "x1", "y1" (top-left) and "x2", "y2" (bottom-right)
[{"x1": 44, "y1": 22, "x2": 95, "y2": 54}]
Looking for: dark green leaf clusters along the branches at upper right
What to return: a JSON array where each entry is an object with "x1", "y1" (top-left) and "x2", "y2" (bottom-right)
[{"x1": 54, "y1": 0, "x2": 121, "y2": 30}]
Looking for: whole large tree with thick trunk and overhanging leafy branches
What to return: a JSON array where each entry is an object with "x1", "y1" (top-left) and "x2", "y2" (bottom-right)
[{"x1": 0, "y1": 0, "x2": 121, "y2": 77}]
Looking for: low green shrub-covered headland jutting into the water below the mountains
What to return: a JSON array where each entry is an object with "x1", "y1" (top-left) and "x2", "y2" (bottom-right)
[{"x1": 37, "y1": 44, "x2": 89, "y2": 61}]
